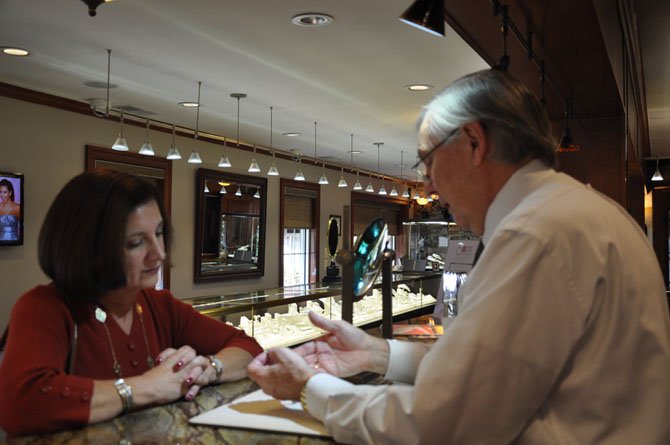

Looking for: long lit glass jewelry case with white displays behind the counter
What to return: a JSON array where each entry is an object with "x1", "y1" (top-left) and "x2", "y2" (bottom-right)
[{"x1": 183, "y1": 273, "x2": 441, "y2": 349}]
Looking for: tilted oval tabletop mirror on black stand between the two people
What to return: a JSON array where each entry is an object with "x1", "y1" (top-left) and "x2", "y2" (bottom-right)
[{"x1": 353, "y1": 218, "x2": 388, "y2": 300}]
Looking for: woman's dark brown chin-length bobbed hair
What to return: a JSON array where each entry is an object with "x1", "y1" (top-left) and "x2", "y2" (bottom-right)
[{"x1": 38, "y1": 169, "x2": 172, "y2": 300}]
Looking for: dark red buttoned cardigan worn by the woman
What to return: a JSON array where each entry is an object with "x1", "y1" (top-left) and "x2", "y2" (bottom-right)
[{"x1": 0, "y1": 285, "x2": 262, "y2": 435}]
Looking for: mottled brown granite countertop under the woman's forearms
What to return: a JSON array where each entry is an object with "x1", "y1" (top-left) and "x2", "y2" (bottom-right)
[{"x1": 7, "y1": 379, "x2": 335, "y2": 445}]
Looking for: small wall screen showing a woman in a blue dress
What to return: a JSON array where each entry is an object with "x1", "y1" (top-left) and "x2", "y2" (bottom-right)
[{"x1": 0, "y1": 172, "x2": 25, "y2": 246}]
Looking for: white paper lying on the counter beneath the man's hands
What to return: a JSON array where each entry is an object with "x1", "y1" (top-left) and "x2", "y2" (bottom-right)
[{"x1": 189, "y1": 389, "x2": 332, "y2": 437}]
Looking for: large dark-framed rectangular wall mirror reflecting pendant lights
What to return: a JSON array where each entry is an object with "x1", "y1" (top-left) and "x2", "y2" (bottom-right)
[{"x1": 193, "y1": 168, "x2": 267, "y2": 282}]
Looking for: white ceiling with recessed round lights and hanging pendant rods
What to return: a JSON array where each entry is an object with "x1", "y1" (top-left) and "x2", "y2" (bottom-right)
[{"x1": 0, "y1": 0, "x2": 487, "y2": 176}]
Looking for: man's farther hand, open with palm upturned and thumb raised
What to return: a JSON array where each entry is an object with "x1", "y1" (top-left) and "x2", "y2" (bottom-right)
[{"x1": 295, "y1": 312, "x2": 389, "y2": 377}]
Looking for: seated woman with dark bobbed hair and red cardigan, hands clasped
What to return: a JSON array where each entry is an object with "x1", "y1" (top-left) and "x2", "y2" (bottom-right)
[{"x1": 0, "y1": 170, "x2": 262, "y2": 435}]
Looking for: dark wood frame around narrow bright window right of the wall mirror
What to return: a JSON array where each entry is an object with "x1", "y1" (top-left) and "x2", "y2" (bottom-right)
[{"x1": 277, "y1": 178, "x2": 321, "y2": 287}]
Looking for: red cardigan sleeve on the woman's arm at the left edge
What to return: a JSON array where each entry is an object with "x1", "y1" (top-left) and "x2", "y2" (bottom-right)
[{"x1": 0, "y1": 286, "x2": 93, "y2": 436}]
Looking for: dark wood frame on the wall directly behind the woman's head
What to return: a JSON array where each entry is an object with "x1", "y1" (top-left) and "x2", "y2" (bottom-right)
[{"x1": 84, "y1": 145, "x2": 174, "y2": 289}]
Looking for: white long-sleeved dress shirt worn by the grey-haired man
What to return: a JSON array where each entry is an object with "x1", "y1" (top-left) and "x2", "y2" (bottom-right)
[{"x1": 306, "y1": 161, "x2": 670, "y2": 445}]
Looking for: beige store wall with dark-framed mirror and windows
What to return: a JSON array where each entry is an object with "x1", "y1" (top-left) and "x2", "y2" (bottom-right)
[{"x1": 0, "y1": 97, "x2": 372, "y2": 328}]
